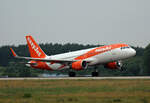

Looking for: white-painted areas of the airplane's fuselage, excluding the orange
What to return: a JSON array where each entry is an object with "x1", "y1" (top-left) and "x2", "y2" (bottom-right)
[{"x1": 46, "y1": 47, "x2": 136, "y2": 70}]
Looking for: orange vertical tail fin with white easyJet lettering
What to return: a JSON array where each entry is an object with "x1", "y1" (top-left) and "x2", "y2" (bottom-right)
[{"x1": 26, "y1": 35, "x2": 46, "y2": 58}]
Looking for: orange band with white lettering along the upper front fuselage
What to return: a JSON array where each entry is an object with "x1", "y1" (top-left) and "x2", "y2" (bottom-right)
[{"x1": 75, "y1": 44, "x2": 128, "y2": 60}]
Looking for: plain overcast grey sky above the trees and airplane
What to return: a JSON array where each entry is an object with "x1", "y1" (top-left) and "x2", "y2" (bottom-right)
[{"x1": 0, "y1": 0, "x2": 150, "y2": 47}]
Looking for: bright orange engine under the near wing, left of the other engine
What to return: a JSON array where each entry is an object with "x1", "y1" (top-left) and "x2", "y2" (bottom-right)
[{"x1": 71, "y1": 60, "x2": 87, "y2": 70}]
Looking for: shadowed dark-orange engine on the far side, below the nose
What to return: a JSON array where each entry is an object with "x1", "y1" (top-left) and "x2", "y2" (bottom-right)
[{"x1": 104, "y1": 61, "x2": 122, "y2": 69}]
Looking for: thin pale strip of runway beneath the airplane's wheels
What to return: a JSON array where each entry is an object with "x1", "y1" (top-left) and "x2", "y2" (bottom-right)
[{"x1": 0, "y1": 76, "x2": 150, "y2": 80}]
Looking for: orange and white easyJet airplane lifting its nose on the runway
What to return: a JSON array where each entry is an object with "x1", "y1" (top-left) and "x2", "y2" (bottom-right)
[{"x1": 10, "y1": 35, "x2": 136, "y2": 77}]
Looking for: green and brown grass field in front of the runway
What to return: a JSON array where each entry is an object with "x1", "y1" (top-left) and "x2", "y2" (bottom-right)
[{"x1": 0, "y1": 79, "x2": 150, "y2": 103}]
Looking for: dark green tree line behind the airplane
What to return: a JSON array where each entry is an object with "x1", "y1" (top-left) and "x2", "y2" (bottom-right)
[{"x1": 0, "y1": 43, "x2": 150, "y2": 77}]
